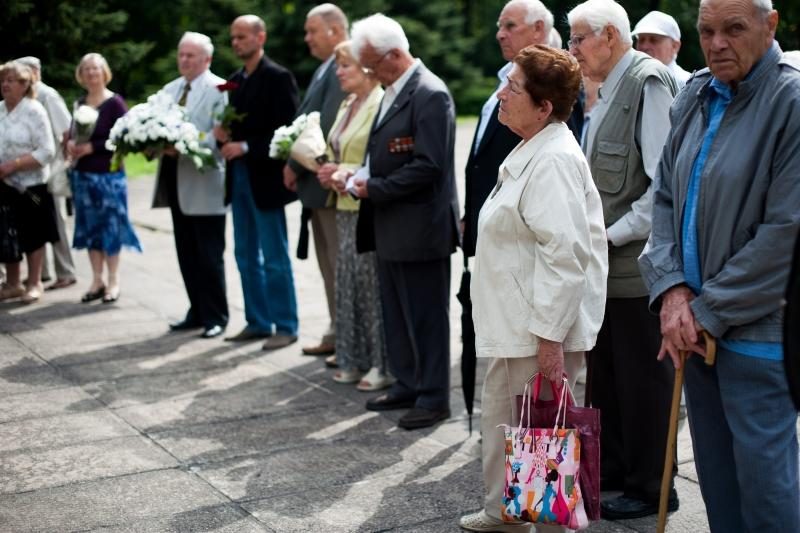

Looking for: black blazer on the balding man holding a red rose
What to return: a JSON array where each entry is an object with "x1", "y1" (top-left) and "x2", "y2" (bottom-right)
[{"x1": 225, "y1": 56, "x2": 299, "y2": 209}]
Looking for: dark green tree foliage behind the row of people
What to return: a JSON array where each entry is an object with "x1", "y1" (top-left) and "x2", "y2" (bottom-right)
[{"x1": 0, "y1": 0, "x2": 800, "y2": 115}]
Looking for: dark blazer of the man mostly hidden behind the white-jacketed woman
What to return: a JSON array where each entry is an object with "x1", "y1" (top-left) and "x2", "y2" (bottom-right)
[{"x1": 461, "y1": 94, "x2": 583, "y2": 257}]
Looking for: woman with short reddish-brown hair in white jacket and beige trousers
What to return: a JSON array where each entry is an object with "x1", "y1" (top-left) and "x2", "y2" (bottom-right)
[{"x1": 460, "y1": 45, "x2": 608, "y2": 532}]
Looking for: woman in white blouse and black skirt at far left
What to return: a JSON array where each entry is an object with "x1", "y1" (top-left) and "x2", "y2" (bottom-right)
[{"x1": 0, "y1": 61, "x2": 58, "y2": 303}]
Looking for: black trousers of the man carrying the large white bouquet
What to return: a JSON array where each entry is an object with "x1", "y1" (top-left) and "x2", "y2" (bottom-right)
[{"x1": 160, "y1": 162, "x2": 228, "y2": 327}]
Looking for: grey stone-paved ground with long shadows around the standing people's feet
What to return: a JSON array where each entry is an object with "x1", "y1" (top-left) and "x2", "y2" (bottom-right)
[{"x1": 0, "y1": 122, "x2": 708, "y2": 533}]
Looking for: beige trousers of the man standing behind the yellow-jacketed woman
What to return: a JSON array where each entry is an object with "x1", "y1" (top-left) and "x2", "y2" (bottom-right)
[{"x1": 311, "y1": 207, "x2": 339, "y2": 344}]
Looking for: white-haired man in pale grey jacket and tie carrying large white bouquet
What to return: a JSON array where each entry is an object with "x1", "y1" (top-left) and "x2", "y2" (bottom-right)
[{"x1": 153, "y1": 32, "x2": 228, "y2": 338}]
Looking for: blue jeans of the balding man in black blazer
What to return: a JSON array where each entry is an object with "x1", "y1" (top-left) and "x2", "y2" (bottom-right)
[{"x1": 231, "y1": 160, "x2": 298, "y2": 335}]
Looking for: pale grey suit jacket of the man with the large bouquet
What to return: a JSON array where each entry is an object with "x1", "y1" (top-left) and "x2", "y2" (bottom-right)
[{"x1": 153, "y1": 70, "x2": 228, "y2": 215}]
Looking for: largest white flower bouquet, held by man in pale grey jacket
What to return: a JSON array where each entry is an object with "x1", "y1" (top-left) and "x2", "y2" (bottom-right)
[{"x1": 106, "y1": 91, "x2": 216, "y2": 170}]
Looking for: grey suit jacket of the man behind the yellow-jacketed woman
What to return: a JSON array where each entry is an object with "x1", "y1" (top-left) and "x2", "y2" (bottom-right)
[{"x1": 289, "y1": 60, "x2": 345, "y2": 209}]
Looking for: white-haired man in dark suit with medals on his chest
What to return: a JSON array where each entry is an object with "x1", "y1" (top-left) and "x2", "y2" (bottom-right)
[{"x1": 349, "y1": 14, "x2": 458, "y2": 429}]
